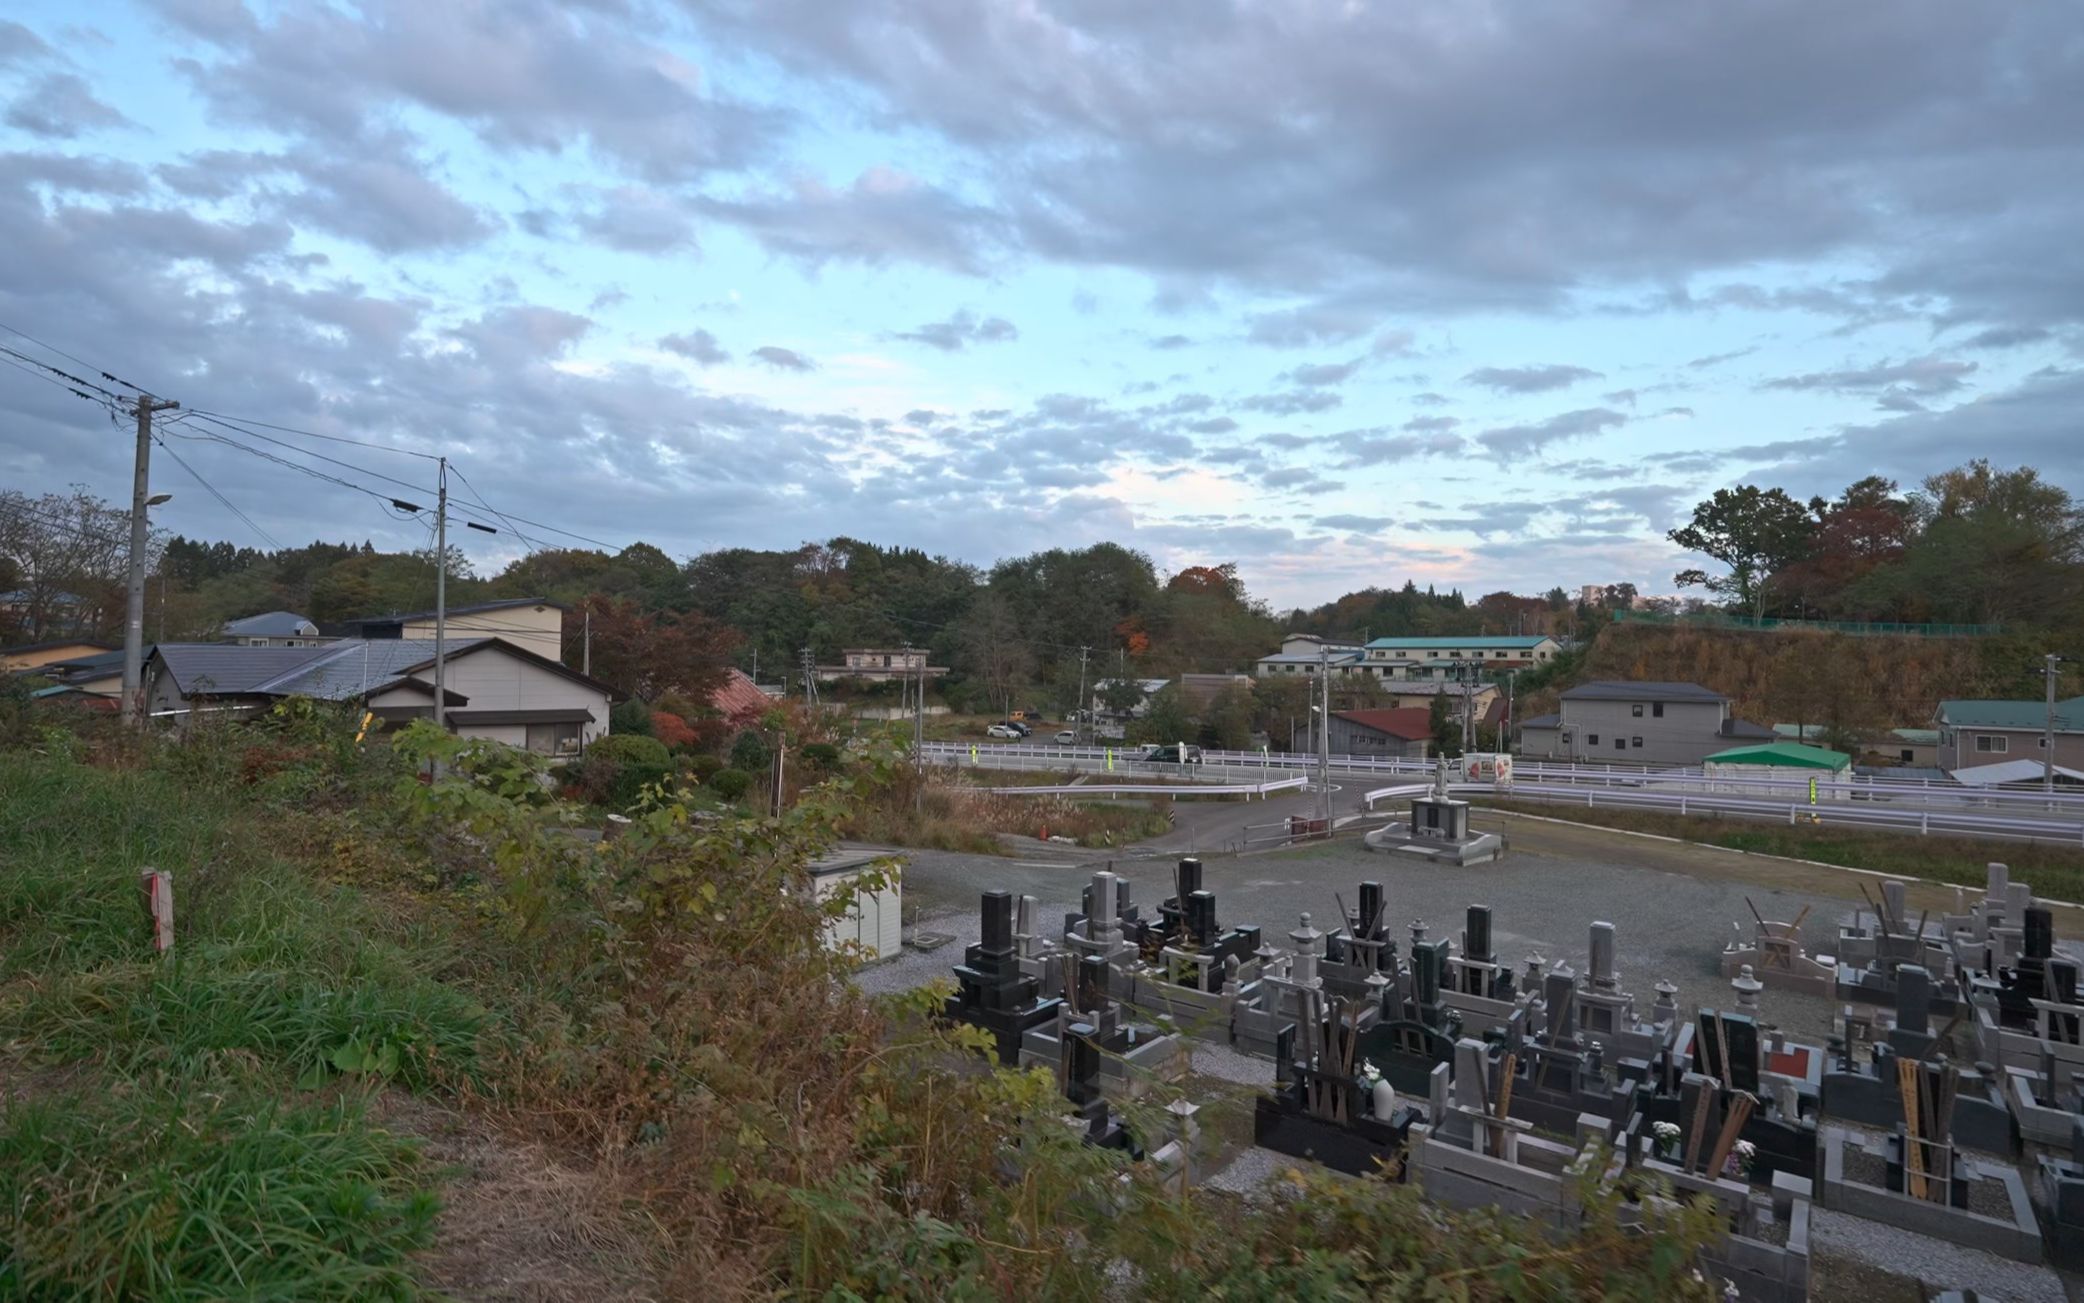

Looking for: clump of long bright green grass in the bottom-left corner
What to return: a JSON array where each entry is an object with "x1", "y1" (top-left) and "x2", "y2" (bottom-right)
[{"x1": 0, "y1": 1080, "x2": 438, "y2": 1299}]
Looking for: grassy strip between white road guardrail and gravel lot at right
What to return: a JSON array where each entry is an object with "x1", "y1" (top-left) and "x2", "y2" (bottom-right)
[{"x1": 1482, "y1": 801, "x2": 2084, "y2": 903}]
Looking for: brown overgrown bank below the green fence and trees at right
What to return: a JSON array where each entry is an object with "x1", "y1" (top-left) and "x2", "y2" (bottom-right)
[{"x1": 1523, "y1": 623, "x2": 2038, "y2": 728}]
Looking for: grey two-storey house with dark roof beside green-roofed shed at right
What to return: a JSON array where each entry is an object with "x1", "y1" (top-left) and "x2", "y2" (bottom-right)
[{"x1": 1519, "y1": 680, "x2": 1778, "y2": 765}]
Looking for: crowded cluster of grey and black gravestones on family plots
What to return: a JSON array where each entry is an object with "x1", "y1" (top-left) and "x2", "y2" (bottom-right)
[{"x1": 946, "y1": 842, "x2": 2084, "y2": 1299}]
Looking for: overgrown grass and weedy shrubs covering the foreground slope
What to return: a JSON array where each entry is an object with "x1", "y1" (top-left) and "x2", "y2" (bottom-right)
[{"x1": 0, "y1": 713, "x2": 1713, "y2": 1299}]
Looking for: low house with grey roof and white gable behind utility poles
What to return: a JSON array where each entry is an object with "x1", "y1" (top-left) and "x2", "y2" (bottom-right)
[{"x1": 144, "y1": 638, "x2": 619, "y2": 757}]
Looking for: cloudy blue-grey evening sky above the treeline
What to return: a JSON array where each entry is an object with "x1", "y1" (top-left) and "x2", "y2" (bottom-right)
[{"x1": 0, "y1": 0, "x2": 2084, "y2": 609}]
